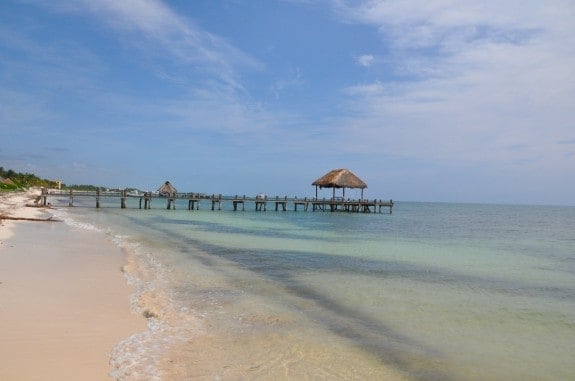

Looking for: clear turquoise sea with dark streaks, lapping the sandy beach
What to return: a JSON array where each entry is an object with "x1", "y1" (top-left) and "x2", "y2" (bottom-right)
[{"x1": 53, "y1": 200, "x2": 575, "y2": 380}]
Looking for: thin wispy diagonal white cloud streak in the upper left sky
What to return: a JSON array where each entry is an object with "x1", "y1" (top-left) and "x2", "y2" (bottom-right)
[{"x1": 42, "y1": 0, "x2": 262, "y2": 90}]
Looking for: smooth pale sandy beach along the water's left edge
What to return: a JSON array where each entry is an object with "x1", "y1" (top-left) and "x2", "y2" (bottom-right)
[{"x1": 0, "y1": 193, "x2": 146, "y2": 380}]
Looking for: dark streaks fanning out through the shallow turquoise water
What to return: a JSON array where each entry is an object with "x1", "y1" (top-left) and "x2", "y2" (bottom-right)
[{"x1": 113, "y1": 208, "x2": 575, "y2": 380}]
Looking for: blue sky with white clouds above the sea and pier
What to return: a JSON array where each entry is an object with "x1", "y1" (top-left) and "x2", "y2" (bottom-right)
[{"x1": 0, "y1": 0, "x2": 575, "y2": 205}]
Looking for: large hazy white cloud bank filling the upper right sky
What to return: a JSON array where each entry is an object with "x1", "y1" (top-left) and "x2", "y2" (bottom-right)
[{"x1": 335, "y1": 1, "x2": 575, "y2": 172}]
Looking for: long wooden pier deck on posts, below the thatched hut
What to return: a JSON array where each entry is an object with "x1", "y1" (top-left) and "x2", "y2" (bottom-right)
[{"x1": 36, "y1": 190, "x2": 394, "y2": 214}]
